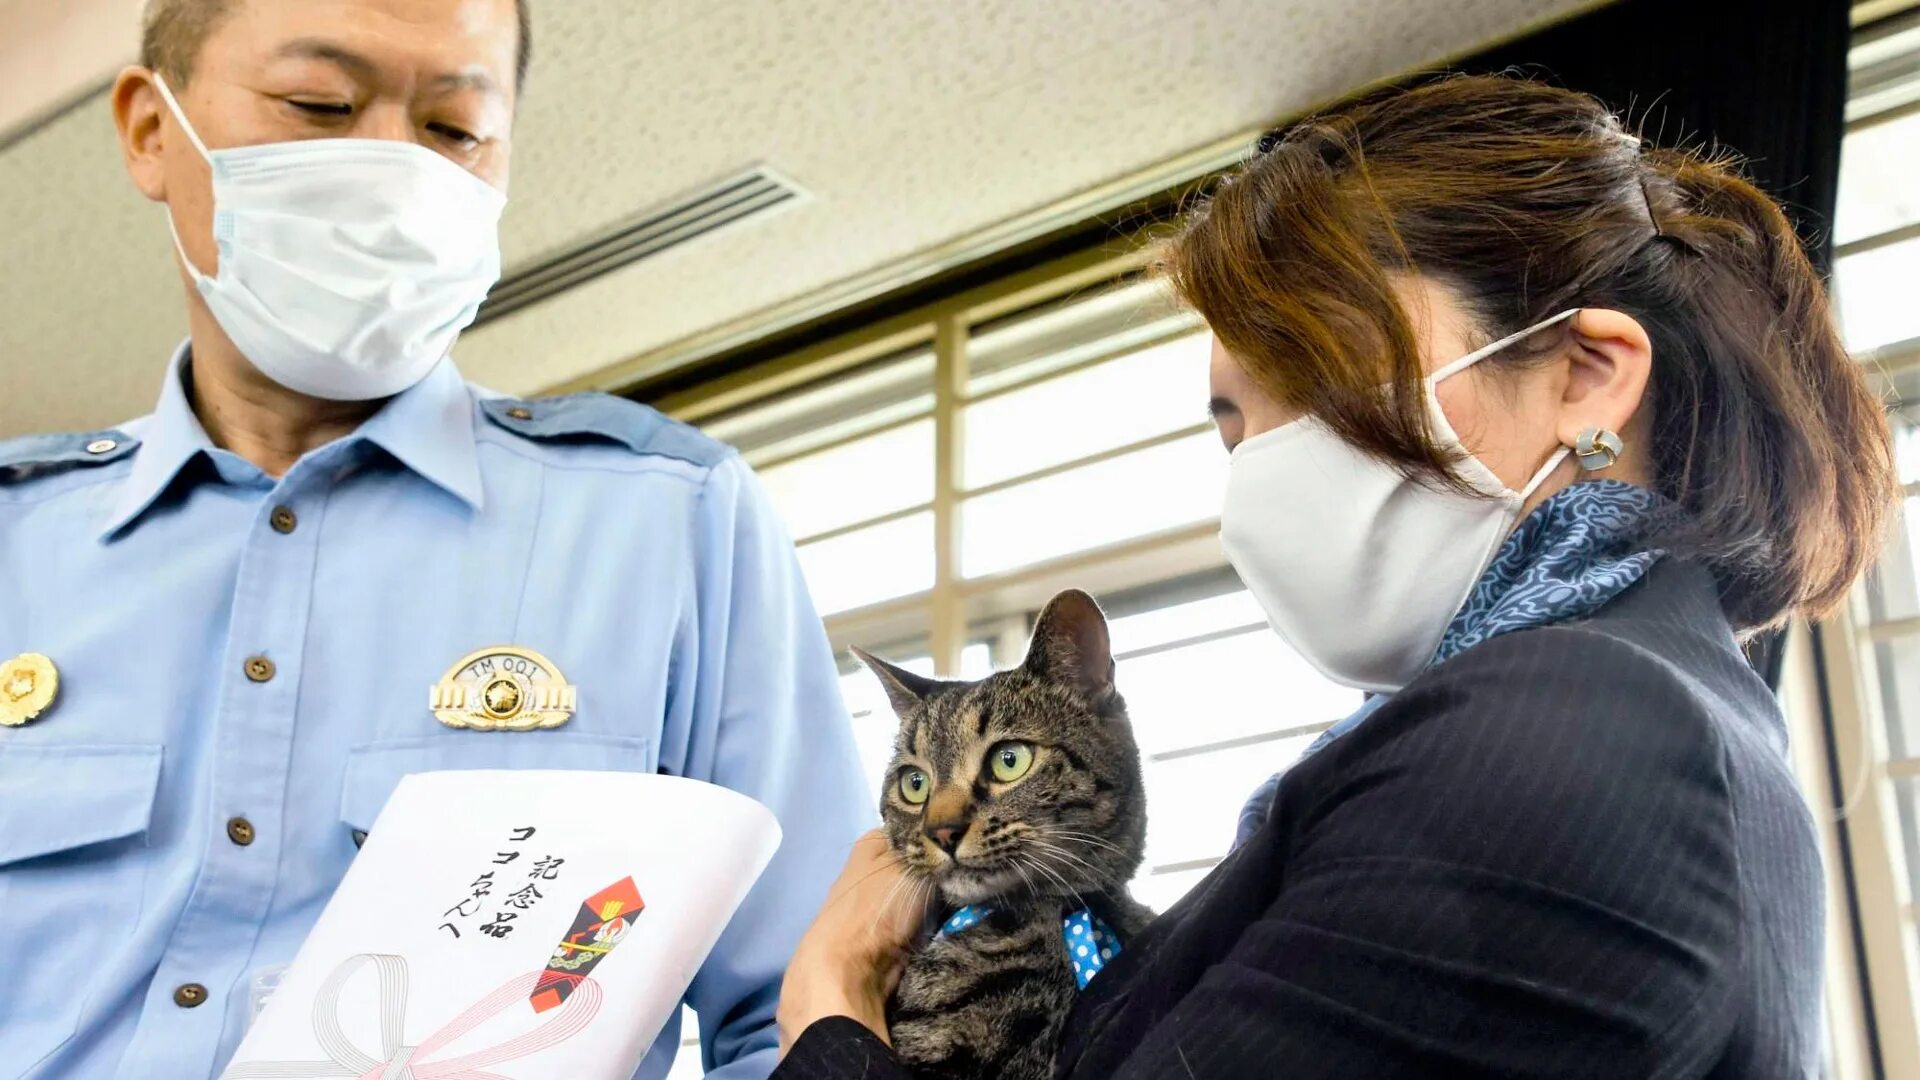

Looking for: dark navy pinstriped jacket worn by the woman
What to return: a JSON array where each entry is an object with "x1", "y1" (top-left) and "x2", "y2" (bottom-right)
[{"x1": 778, "y1": 563, "x2": 1822, "y2": 1080}]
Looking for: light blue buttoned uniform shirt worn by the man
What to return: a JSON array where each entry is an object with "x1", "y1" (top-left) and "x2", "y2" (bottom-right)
[{"x1": 0, "y1": 348, "x2": 872, "y2": 1080}]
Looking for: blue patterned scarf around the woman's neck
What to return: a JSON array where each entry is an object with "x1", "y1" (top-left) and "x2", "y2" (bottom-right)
[{"x1": 1233, "y1": 480, "x2": 1667, "y2": 847}]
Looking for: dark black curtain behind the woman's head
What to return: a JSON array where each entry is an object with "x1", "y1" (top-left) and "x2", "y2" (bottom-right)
[{"x1": 1455, "y1": 0, "x2": 1853, "y2": 688}]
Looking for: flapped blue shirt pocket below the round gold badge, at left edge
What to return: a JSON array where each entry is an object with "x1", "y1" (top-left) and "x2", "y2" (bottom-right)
[{"x1": 0, "y1": 744, "x2": 161, "y2": 1072}]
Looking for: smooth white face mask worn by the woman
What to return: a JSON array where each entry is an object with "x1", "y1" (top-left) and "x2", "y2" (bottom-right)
[{"x1": 1219, "y1": 309, "x2": 1578, "y2": 692}]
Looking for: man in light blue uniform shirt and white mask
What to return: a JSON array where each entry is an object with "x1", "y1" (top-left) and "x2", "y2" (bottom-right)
[{"x1": 0, "y1": 0, "x2": 870, "y2": 1080}]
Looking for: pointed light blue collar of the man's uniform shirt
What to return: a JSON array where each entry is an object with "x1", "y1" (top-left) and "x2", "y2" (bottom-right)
[{"x1": 100, "y1": 342, "x2": 482, "y2": 538}]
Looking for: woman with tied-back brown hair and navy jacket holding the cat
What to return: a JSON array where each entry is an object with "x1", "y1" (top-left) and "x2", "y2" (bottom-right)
[{"x1": 780, "y1": 77, "x2": 1893, "y2": 1078}]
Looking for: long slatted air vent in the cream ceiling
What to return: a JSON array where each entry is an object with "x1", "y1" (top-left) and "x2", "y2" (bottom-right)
[{"x1": 474, "y1": 165, "x2": 803, "y2": 327}]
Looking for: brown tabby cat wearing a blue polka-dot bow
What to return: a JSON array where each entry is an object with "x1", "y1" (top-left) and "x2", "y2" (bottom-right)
[{"x1": 860, "y1": 592, "x2": 1152, "y2": 1080}]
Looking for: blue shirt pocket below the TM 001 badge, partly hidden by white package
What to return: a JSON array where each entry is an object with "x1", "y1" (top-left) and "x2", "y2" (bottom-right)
[{"x1": 340, "y1": 730, "x2": 655, "y2": 834}]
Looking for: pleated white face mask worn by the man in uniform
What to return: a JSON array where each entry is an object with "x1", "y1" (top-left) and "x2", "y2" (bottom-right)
[{"x1": 154, "y1": 75, "x2": 507, "y2": 402}]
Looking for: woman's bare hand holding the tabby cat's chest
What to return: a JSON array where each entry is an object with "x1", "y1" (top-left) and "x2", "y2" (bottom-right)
[{"x1": 778, "y1": 830, "x2": 927, "y2": 1055}]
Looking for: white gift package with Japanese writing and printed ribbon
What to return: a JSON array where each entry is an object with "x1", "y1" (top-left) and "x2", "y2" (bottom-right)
[{"x1": 221, "y1": 771, "x2": 780, "y2": 1080}]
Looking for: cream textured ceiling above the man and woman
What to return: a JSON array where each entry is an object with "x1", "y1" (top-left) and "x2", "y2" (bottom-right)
[{"x1": 0, "y1": 0, "x2": 1590, "y2": 438}]
